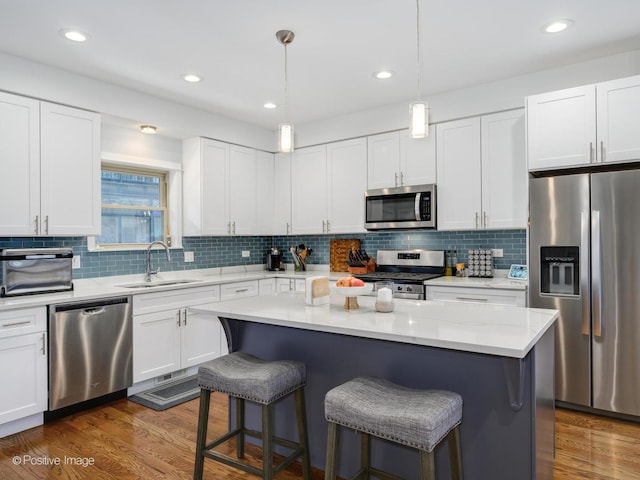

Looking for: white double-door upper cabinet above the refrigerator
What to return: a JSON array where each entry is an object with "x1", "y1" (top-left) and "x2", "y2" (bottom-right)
[{"x1": 527, "y1": 76, "x2": 640, "y2": 170}]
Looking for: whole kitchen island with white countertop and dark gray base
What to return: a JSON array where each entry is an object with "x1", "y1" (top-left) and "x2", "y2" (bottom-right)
[{"x1": 192, "y1": 293, "x2": 558, "y2": 480}]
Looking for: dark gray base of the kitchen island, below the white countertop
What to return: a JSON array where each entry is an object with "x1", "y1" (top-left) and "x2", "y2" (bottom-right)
[{"x1": 220, "y1": 315, "x2": 555, "y2": 480}]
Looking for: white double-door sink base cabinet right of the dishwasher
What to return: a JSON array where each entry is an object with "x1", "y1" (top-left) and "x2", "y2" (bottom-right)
[{"x1": 133, "y1": 285, "x2": 224, "y2": 383}]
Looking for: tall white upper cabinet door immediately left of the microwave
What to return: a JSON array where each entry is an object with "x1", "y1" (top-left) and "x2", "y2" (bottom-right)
[{"x1": 327, "y1": 138, "x2": 367, "y2": 233}]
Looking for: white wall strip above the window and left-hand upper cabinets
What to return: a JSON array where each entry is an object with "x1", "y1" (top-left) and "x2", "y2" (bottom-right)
[{"x1": 0, "y1": 52, "x2": 275, "y2": 151}]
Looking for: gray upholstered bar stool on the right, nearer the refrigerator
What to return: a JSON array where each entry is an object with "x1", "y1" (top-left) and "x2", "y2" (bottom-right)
[{"x1": 324, "y1": 377, "x2": 462, "y2": 480}]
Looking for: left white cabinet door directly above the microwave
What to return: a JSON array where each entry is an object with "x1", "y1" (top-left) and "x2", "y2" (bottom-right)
[{"x1": 367, "y1": 132, "x2": 400, "y2": 189}]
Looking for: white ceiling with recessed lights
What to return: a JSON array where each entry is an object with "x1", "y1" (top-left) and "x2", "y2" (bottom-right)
[{"x1": 0, "y1": 0, "x2": 640, "y2": 130}]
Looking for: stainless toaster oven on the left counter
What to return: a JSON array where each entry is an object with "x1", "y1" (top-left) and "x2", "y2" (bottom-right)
[{"x1": 0, "y1": 247, "x2": 73, "y2": 297}]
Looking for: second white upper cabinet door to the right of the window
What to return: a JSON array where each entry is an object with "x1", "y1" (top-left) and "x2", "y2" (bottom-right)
[{"x1": 229, "y1": 145, "x2": 258, "y2": 235}]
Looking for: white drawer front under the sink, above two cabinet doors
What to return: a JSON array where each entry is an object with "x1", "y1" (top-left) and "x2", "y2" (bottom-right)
[{"x1": 133, "y1": 285, "x2": 220, "y2": 315}]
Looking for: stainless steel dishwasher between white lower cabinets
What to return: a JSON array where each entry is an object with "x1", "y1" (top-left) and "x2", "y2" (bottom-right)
[{"x1": 49, "y1": 297, "x2": 133, "y2": 410}]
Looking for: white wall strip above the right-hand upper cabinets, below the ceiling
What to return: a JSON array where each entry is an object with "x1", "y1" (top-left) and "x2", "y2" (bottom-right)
[{"x1": 295, "y1": 50, "x2": 640, "y2": 148}]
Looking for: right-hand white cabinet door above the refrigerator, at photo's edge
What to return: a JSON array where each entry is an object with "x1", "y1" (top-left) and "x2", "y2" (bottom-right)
[{"x1": 596, "y1": 75, "x2": 640, "y2": 162}]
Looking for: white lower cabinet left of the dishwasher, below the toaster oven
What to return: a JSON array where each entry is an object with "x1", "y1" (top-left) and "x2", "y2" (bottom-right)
[{"x1": 0, "y1": 307, "x2": 48, "y2": 437}]
